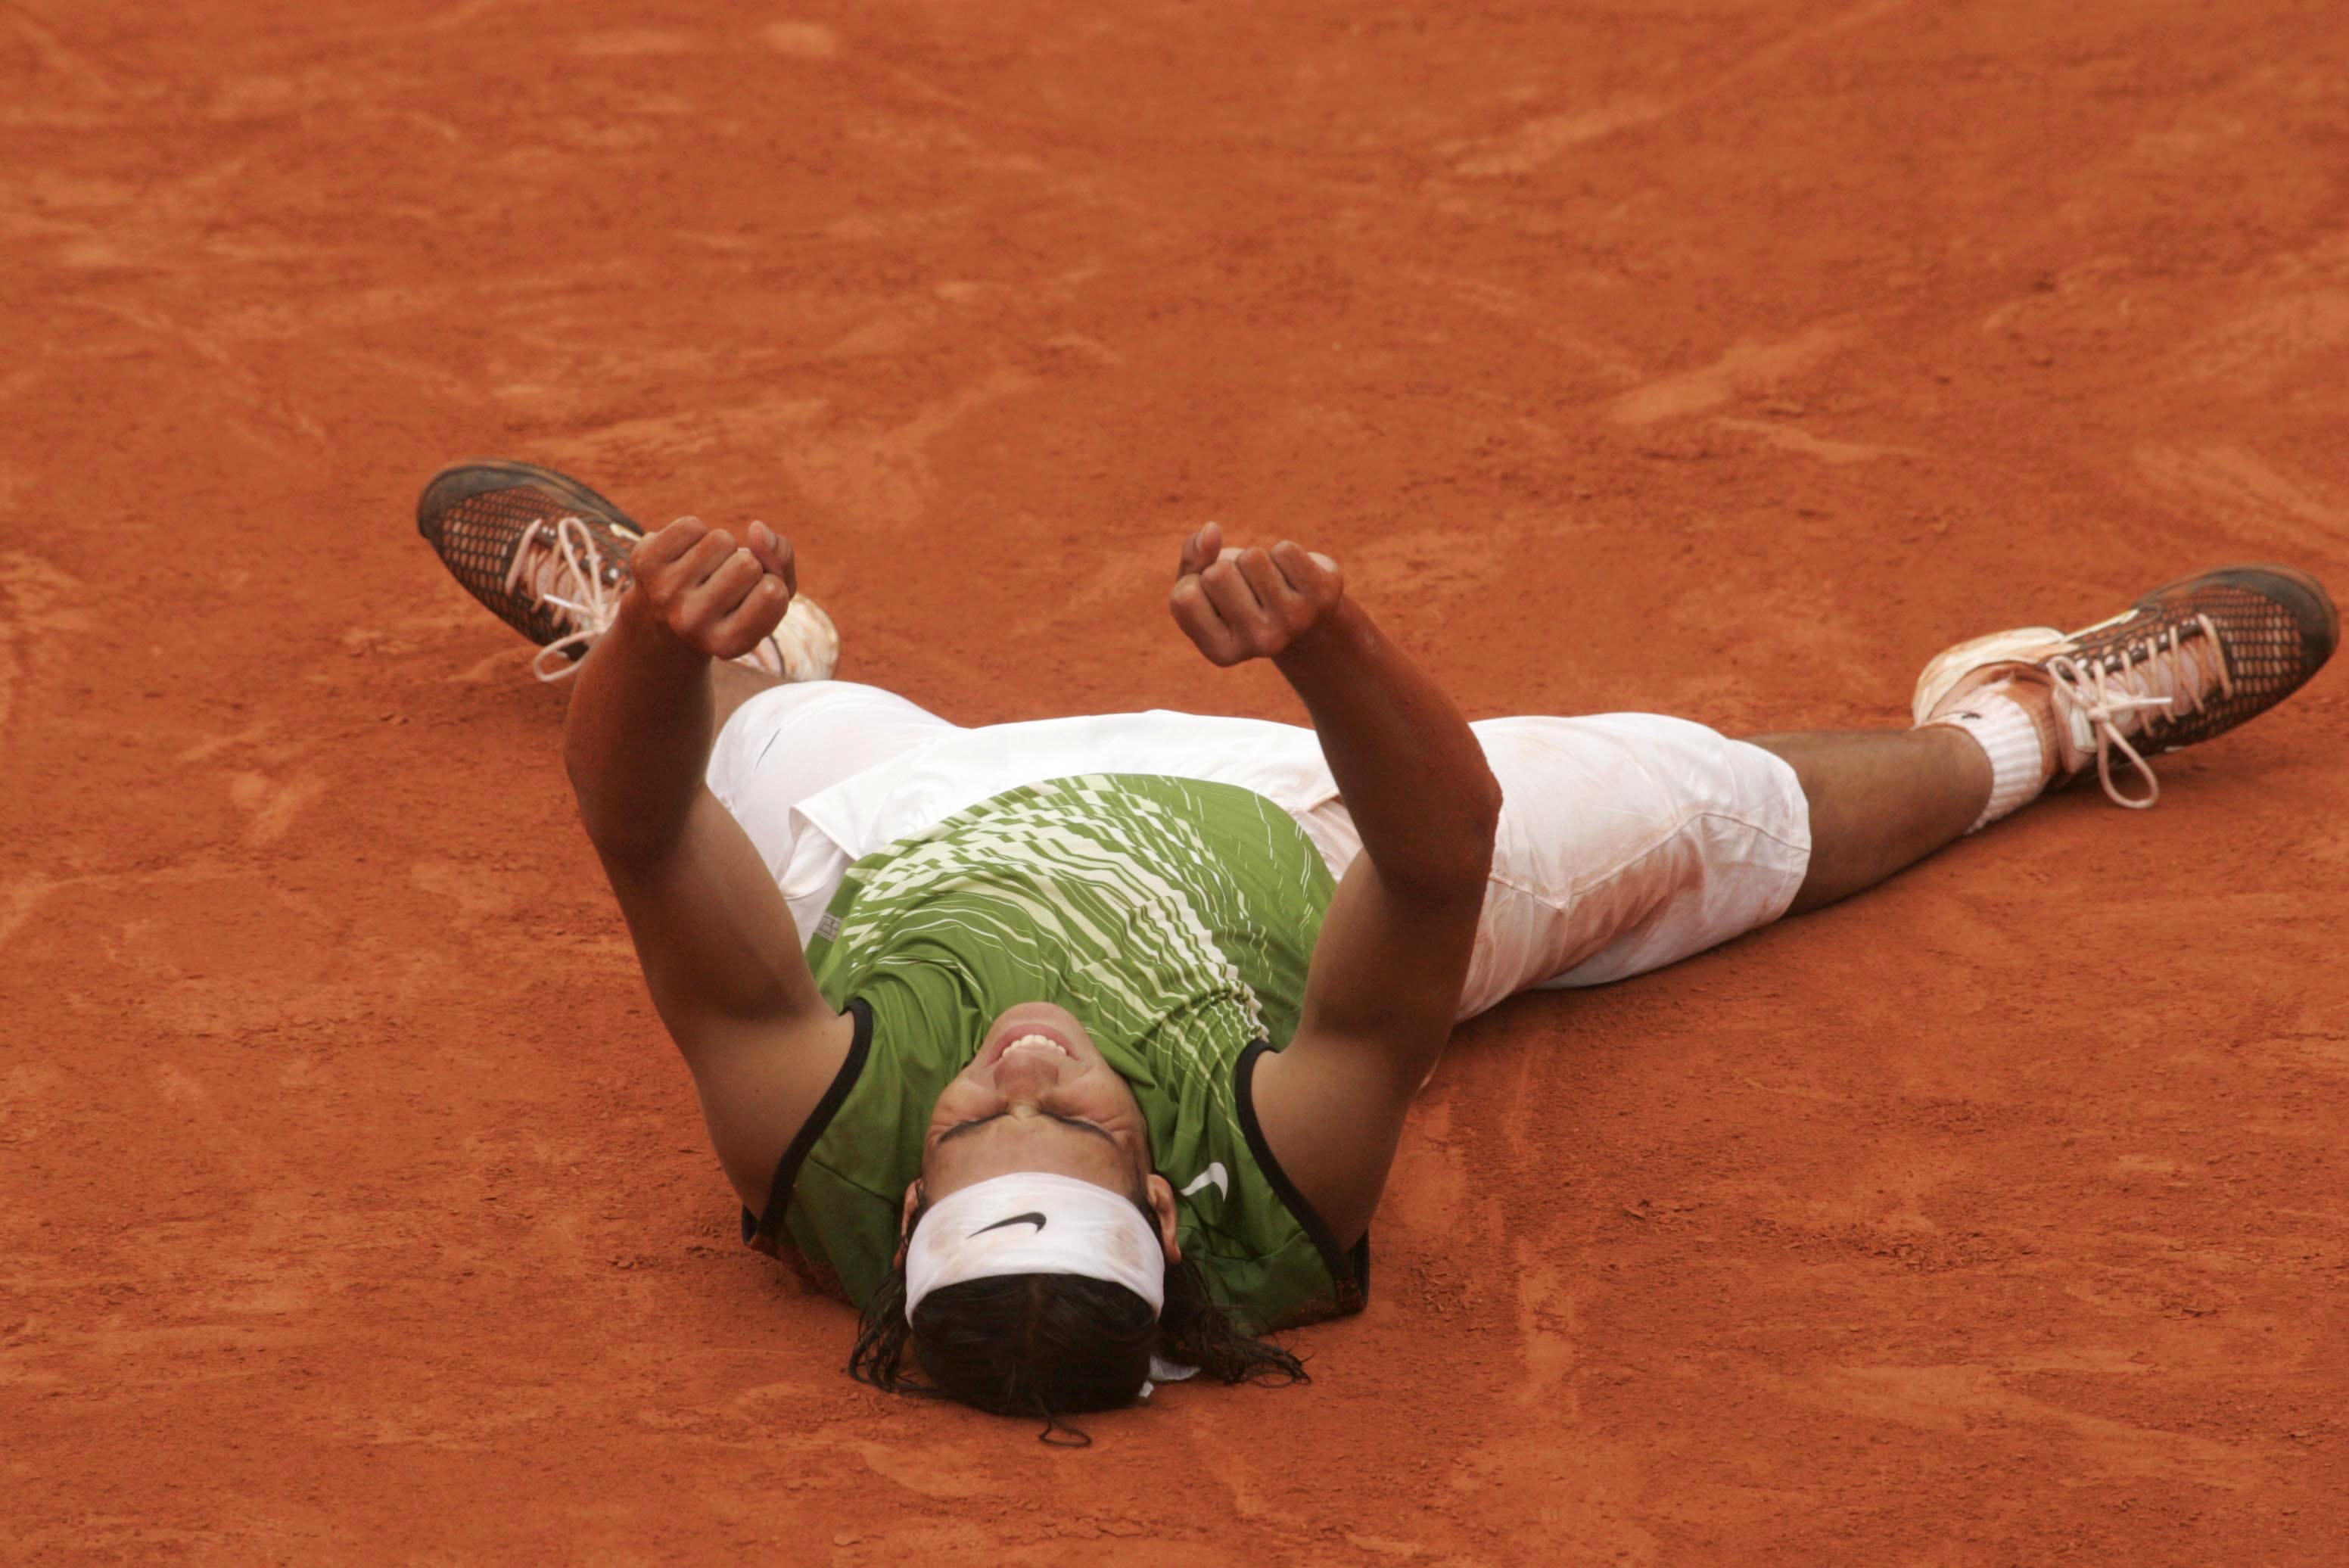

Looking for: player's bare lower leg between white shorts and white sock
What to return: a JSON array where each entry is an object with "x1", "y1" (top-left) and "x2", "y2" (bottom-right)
[{"x1": 1745, "y1": 725, "x2": 1990, "y2": 916}]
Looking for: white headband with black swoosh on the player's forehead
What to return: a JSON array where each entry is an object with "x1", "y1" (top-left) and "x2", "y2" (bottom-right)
[{"x1": 904, "y1": 1171, "x2": 1168, "y2": 1321}]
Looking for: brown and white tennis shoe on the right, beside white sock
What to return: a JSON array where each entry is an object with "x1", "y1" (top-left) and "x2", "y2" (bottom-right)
[{"x1": 1912, "y1": 566, "x2": 2340, "y2": 810}]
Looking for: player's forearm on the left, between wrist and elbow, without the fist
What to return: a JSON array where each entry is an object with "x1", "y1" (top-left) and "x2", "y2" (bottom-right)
[{"x1": 564, "y1": 592, "x2": 712, "y2": 857}]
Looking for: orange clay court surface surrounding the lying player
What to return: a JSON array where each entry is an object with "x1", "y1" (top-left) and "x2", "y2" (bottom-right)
[{"x1": 0, "y1": 0, "x2": 2349, "y2": 1566}]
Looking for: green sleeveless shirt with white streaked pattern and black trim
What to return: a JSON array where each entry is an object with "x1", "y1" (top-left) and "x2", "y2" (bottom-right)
[{"x1": 742, "y1": 775, "x2": 1370, "y2": 1331}]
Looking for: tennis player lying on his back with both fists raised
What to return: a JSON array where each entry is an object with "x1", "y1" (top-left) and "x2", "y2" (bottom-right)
[{"x1": 418, "y1": 462, "x2": 2340, "y2": 1420}]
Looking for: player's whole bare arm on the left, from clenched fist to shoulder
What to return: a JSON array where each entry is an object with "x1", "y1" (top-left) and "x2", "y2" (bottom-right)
[{"x1": 564, "y1": 521, "x2": 853, "y2": 1212}]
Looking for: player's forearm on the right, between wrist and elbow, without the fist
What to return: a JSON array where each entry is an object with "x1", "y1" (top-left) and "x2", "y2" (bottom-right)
[{"x1": 1273, "y1": 599, "x2": 1501, "y2": 890}]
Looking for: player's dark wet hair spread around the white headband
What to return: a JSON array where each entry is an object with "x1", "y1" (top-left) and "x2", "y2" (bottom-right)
[{"x1": 848, "y1": 1197, "x2": 1311, "y2": 1448}]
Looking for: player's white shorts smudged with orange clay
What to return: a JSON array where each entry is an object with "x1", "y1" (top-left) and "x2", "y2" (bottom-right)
[{"x1": 709, "y1": 681, "x2": 1811, "y2": 1019}]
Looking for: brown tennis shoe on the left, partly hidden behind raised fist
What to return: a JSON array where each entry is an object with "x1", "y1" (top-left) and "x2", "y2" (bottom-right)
[{"x1": 415, "y1": 462, "x2": 841, "y2": 681}]
